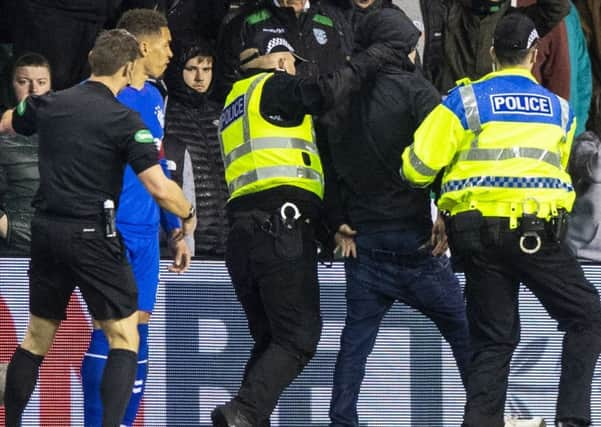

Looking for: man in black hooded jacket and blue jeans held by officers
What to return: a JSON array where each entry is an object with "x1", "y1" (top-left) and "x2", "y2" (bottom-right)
[{"x1": 330, "y1": 9, "x2": 470, "y2": 427}]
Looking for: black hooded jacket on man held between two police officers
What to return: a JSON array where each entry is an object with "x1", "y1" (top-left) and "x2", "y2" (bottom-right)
[{"x1": 330, "y1": 9, "x2": 440, "y2": 235}]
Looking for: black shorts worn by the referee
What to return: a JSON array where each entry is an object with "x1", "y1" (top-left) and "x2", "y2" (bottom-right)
[{"x1": 29, "y1": 215, "x2": 138, "y2": 320}]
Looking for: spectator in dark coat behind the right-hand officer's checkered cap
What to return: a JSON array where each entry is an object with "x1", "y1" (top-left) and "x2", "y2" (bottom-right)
[{"x1": 421, "y1": 0, "x2": 569, "y2": 93}]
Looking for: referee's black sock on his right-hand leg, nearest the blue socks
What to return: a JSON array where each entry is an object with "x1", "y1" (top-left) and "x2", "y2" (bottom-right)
[{"x1": 100, "y1": 349, "x2": 138, "y2": 427}]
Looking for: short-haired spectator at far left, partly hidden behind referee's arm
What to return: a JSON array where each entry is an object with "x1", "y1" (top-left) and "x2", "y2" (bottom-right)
[{"x1": 0, "y1": 53, "x2": 51, "y2": 257}]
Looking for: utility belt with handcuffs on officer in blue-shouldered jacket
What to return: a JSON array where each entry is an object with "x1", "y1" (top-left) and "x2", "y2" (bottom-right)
[{"x1": 450, "y1": 198, "x2": 568, "y2": 254}]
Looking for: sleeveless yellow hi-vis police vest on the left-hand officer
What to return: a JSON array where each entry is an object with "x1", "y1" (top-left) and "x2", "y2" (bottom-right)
[{"x1": 219, "y1": 73, "x2": 324, "y2": 200}]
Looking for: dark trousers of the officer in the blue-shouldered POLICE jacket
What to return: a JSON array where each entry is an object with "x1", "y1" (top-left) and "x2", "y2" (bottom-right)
[{"x1": 457, "y1": 219, "x2": 601, "y2": 427}]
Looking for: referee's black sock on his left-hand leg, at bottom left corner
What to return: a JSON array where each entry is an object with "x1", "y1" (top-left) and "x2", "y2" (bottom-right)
[{"x1": 4, "y1": 347, "x2": 44, "y2": 427}]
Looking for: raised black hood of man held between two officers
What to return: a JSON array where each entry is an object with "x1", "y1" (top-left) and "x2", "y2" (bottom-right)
[{"x1": 355, "y1": 8, "x2": 421, "y2": 70}]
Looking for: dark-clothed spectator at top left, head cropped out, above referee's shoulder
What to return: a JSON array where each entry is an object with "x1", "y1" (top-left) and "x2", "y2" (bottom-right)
[{"x1": 13, "y1": 0, "x2": 114, "y2": 90}]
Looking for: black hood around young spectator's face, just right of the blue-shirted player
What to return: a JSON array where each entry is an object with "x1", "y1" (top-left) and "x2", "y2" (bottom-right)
[{"x1": 164, "y1": 40, "x2": 215, "y2": 106}]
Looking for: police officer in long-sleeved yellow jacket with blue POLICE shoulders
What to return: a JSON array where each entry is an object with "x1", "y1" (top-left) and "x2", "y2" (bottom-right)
[{"x1": 402, "y1": 13, "x2": 601, "y2": 427}]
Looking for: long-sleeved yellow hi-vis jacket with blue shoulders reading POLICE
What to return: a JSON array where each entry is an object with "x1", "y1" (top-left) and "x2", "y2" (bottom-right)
[{"x1": 402, "y1": 69, "x2": 575, "y2": 228}]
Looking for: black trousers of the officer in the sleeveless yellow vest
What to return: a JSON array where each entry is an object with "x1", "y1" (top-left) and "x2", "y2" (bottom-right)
[{"x1": 226, "y1": 213, "x2": 321, "y2": 425}]
